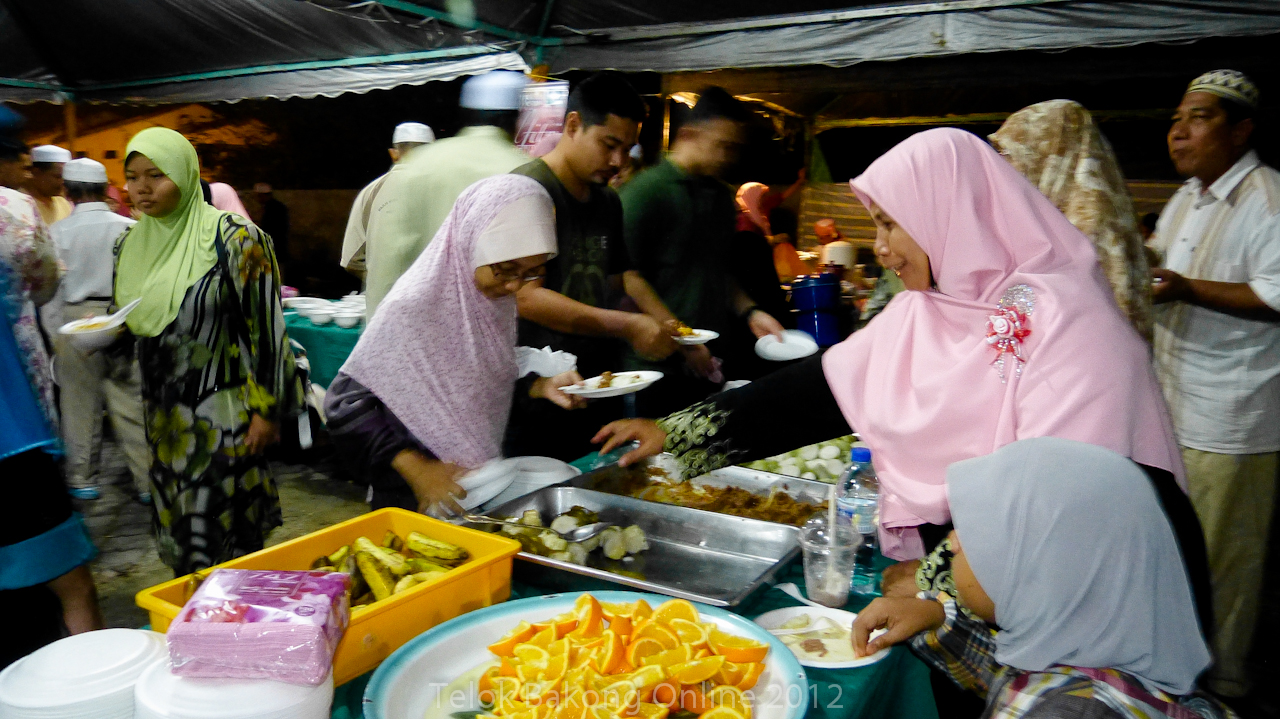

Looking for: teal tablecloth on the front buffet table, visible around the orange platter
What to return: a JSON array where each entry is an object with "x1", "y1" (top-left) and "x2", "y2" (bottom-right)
[{"x1": 333, "y1": 454, "x2": 938, "y2": 719}]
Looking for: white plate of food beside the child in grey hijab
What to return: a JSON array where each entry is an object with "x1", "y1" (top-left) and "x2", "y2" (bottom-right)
[{"x1": 755, "y1": 606, "x2": 890, "y2": 669}]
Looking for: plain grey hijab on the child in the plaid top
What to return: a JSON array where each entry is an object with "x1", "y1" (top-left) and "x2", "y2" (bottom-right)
[{"x1": 947, "y1": 438, "x2": 1210, "y2": 695}]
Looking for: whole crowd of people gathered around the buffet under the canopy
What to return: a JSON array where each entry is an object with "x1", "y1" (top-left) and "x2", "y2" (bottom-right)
[{"x1": 0, "y1": 64, "x2": 1280, "y2": 719}]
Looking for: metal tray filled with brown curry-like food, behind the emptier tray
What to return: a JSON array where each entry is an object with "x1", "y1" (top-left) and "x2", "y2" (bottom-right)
[{"x1": 568, "y1": 455, "x2": 831, "y2": 527}]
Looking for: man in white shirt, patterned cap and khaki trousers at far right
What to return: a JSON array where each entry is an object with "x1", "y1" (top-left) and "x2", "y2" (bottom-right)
[{"x1": 1149, "y1": 70, "x2": 1280, "y2": 697}]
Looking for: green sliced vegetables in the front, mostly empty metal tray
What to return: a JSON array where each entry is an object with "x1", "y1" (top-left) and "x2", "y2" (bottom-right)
[{"x1": 497, "y1": 505, "x2": 649, "y2": 564}]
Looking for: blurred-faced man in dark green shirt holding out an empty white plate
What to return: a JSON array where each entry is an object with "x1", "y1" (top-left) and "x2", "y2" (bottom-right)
[{"x1": 621, "y1": 87, "x2": 782, "y2": 417}]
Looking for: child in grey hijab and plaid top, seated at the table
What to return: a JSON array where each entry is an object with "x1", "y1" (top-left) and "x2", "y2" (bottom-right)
[{"x1": 854, "y1": 438, "x2": 1226, "y2": 719}]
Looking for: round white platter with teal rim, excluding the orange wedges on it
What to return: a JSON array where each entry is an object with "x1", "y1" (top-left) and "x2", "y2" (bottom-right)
[{"x1": 364, "y1": 591, "x2": 810, "y2": 719}]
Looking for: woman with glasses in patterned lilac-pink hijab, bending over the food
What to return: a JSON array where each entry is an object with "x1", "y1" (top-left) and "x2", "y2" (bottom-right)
[{"x1": 325, "y1": 175, "x2": 581, "y2": 513}]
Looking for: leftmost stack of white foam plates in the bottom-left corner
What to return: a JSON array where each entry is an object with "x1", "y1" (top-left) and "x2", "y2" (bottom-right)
[{"x1": 0, "y1": 629, "x2": 169, "y2": 719}]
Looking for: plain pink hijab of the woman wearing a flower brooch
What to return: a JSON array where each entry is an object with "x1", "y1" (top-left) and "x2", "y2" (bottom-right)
[{"x1": 823, "y1": 129, "x2": 1185, "y2": 559}]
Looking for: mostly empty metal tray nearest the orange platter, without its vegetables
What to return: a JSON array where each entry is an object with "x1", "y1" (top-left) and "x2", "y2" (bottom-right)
[{"x1": 475, "y1": 486, "x2": 800, "y2": 606}]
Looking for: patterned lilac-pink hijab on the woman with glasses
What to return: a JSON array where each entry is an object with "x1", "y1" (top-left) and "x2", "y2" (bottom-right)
[{"x1": 342, "y1": 175, "x2": 556, "y2": 468}]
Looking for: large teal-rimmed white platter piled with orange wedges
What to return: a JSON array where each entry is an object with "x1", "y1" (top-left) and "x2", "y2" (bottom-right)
[{"x1": 364, "y1": 591, "x2": 810, "y2": 719}]
